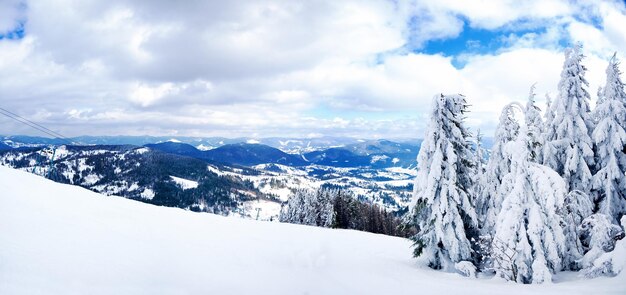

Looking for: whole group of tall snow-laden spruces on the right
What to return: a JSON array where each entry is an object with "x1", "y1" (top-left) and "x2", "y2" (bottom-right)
[{"x1": 406, "y1": 45, "x2": 626, "y2": 283}]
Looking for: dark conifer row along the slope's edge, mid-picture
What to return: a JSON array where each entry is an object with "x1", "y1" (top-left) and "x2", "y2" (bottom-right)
[{"x1": 279, "y1": 188, "x2": 413, "y2": 237}]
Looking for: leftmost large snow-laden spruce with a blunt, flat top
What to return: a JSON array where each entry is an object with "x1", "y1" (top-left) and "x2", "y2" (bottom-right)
[{"x1": 412, "y1": 94, "x2": 477, "y2": 270}]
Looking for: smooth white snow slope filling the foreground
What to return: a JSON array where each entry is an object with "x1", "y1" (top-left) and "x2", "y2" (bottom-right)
[{"x1": 0, "y1": 166, "x2": 626, "y2": 295}]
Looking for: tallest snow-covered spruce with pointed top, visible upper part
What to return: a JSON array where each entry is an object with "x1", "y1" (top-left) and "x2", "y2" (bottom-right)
[{"x1": 544, "y1": 45, "x2": 594, "y2": 194}]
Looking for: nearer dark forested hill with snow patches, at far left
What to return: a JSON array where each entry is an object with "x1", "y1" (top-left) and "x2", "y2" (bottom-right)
[{"x1": 0, "y1": 145, "x2": 265, "y2": 214}]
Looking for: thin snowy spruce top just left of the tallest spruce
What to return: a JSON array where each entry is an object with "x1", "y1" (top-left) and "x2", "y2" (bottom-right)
[{"x1": 524, "y1": 85, "x2": 544, "y2": 163}]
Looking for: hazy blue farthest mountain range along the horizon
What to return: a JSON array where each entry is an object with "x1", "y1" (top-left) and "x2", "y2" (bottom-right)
[{"x1": 0, "y1": 136, "x2": 492, "y2": 168}]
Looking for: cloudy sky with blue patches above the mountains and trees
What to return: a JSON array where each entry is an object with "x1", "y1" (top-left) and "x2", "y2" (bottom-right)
[{"x1": 0, "y1": 0, "x2": 626, "y2": 138}]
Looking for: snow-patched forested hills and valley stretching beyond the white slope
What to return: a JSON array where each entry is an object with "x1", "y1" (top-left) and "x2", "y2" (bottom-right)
[{"x1": 0, "y1": 141, "x2": 415, "y2": 220}]
